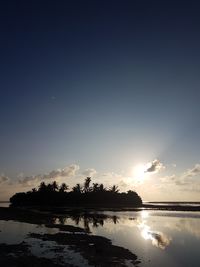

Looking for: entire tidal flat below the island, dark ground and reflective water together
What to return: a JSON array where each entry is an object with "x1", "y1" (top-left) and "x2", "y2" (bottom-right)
[{"x1": 0, "y1": 208, "x2": 200, "y2": 267}]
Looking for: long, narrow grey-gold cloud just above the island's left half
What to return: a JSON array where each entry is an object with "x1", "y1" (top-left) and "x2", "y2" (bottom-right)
[{"x1": 18, "y1": 164, "x2": 79, "y2": 186}]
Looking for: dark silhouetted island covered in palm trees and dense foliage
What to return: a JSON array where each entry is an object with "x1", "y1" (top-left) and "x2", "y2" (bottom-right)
[{"x1": 10, "y1": 177, "x2": 142, "y2": 207}]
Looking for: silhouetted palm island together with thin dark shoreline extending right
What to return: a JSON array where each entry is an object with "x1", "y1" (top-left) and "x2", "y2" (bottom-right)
[{"x1": 7, "y1": 177, "x2": 200, "y2": 212}]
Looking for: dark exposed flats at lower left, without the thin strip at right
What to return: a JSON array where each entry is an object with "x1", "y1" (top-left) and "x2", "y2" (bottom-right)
[{"x1": 0, "y1": 208, "x2": 140, "y2": 267}]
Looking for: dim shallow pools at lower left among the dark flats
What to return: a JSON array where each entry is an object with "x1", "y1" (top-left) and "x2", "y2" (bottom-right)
[{"x1": 0, "y1": 220, "x2": 88, "y2": 267}]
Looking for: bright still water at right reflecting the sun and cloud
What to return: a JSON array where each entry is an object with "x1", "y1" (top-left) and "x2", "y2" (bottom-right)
[{"x1": 65, "y1": 211, "x2": 200, "y2": 267}]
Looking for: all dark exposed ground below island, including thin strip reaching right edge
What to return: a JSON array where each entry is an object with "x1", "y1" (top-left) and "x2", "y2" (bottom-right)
[{"x1": 0, "y1": 204, "x2": 200, "y2": 267}]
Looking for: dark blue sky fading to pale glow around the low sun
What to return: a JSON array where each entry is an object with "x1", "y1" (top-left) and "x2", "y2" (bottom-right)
[{"x1": 0, "y1": 0, "x2": 200, "y2": 201}]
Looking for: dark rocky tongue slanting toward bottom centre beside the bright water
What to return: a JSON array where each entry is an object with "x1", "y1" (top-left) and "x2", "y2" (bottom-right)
[{"x1": 30, "y1": 233, "x2": 140, "y2": 267}]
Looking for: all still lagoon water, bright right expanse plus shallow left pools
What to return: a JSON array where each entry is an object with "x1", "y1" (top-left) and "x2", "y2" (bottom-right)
[{"x1": 0, "y1": 210, "x2": 200, "y2": 267}]
